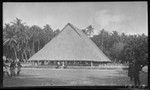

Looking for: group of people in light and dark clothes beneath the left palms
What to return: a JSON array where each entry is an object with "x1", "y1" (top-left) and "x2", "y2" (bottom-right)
[{"x1": 3, "y1": 57, "x2": 22, "y2": 77}]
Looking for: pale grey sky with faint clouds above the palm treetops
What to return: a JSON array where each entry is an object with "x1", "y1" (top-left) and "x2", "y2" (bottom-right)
[{"x1": 3, "y1": 1, "x2": 148, "y2": 35}]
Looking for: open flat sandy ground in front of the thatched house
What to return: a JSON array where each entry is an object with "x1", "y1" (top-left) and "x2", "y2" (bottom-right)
[{"x1": 3, "y1": 68, "x2": 148, "y2": 87}]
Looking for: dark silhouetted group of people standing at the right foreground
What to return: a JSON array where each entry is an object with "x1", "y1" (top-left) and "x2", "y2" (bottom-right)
[{"x1": 128, "y1": 61, "x2": 142, "y2": 86}]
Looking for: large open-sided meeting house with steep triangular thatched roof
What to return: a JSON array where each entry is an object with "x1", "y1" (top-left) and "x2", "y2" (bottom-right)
[{"x1": 29, "y1": 23, "x2": 110, "y2": 66}]
